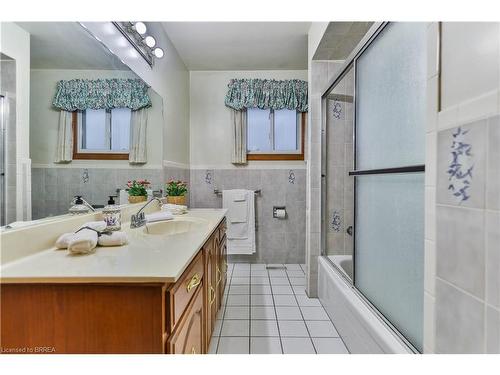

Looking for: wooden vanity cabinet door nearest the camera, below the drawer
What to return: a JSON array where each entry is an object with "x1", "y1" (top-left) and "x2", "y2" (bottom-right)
[{"x1": 167, "y1": 289, "x2": 205, "y2": 354}]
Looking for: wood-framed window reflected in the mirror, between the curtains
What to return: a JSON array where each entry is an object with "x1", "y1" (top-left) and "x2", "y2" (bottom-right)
[{"x1": 73, "y1": 108, "x2": 131, "y2": 160}]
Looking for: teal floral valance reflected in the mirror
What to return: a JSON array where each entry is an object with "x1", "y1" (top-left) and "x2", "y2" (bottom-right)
[{"x1": 53, "y1": 78, "x2": 151, "y2": 111}]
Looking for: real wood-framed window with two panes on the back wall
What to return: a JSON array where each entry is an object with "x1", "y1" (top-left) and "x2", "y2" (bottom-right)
[{"x1": 246, "y1": 108, "x2": 305, "y2": 160}]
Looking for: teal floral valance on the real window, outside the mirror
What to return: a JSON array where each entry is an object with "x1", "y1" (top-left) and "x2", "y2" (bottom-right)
[{"x1": 225, "y1": 79, "x2": 307, "y2": 112}]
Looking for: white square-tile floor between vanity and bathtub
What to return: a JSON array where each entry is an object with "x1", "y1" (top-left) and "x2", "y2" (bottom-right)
[{"x1": 209, "y1": 263, "x2": 348, "y2": 354}]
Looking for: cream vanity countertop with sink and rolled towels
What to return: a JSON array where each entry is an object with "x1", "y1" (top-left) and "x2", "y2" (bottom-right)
[{"x1": 0, "y1": 209, "x2": 226, "y2": 283}]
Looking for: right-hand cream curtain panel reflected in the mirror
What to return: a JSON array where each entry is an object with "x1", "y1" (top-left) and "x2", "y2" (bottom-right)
[{"x1": 128, "y1": 108, "x2": 148, "y2": 164}]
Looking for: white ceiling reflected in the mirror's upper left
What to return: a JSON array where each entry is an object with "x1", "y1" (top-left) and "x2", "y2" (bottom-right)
[{"x1": 17, "y1": 22, "x2": 129, "y2": 70}]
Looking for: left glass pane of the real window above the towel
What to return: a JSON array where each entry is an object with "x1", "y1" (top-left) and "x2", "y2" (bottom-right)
[{"x1": 247, "y1": 108, "x2": 272, "y2": 151}]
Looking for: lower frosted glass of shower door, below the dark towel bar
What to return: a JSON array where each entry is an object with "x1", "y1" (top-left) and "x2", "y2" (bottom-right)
[{"x1": 354, "y1": 173, "x2": 424, "y2": 350}]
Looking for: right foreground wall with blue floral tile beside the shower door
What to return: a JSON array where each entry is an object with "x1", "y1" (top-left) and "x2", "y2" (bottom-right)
[{"x1": 424, "y1": 23, "x2": 500, "y2": 353}]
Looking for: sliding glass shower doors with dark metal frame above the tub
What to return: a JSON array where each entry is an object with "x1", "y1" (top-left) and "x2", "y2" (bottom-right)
[{"x1": 322, "y1": 23, "x2": 426, "y2": 351}]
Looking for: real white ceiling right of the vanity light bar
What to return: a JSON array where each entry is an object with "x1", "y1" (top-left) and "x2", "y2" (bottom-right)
[{"x1": 162, "y1": 22, "x2": 310, "y2": 70}]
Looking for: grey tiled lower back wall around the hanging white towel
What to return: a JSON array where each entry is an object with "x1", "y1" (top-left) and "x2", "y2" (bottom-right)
[{"x1": 190, "y1": 168, "x2": 306, "y2": 263}]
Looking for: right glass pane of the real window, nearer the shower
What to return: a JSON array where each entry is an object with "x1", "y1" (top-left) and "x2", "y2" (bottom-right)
[{"x1": 274, "y1": 109, "x2": 298, "y2": 151}]
